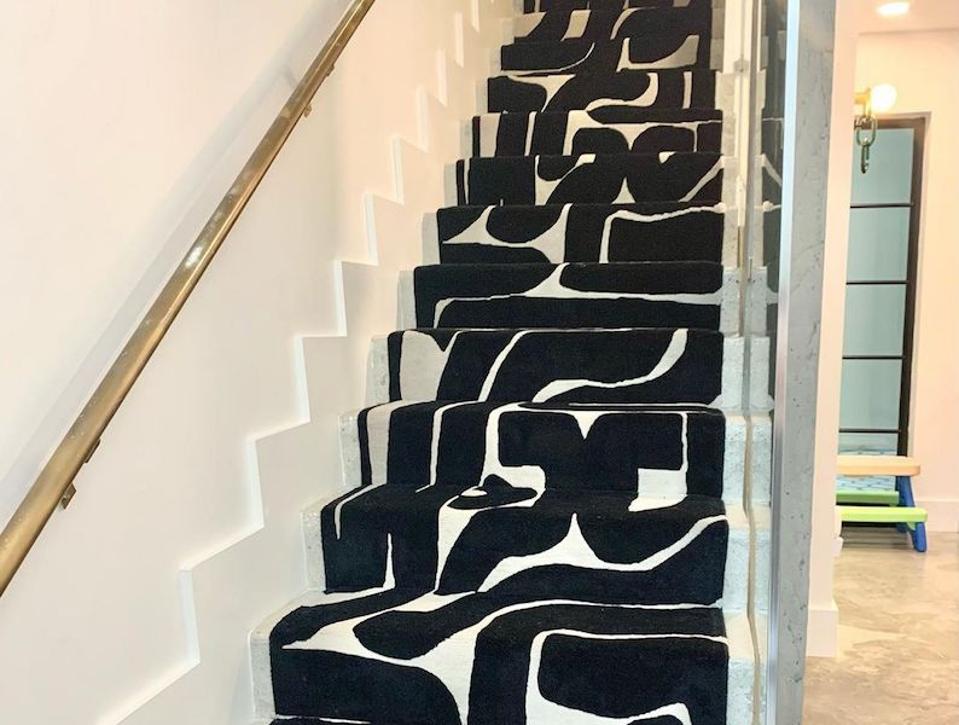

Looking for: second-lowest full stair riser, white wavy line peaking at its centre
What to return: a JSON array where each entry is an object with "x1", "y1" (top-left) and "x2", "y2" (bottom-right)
[{"x1": 318, "y1": 485, "x2": 749, "y2": 592}]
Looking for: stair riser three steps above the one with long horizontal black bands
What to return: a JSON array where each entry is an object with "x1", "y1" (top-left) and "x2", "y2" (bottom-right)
[{"x1": 469, "y1": 111, "x2": 734, "y2": 158}]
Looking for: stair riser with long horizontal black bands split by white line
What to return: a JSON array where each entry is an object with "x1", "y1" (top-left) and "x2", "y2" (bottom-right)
[{"x1": 399, "y1": 265, "x2": 739, "y2": 333}]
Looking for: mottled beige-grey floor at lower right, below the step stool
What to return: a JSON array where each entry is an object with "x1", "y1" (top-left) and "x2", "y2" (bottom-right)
[{"x1": 803, "y1": 527, "x2": 959, "y2": 725}]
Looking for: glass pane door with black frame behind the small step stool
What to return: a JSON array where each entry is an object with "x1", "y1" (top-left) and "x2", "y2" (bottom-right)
[{"x1": 839, "y1": 119, "x2": 924, "y2": 454}]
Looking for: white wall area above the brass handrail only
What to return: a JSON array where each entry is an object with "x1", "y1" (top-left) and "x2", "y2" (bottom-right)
[{"x1": 0, "y1": 0, "x2": 347, "y2": 521}]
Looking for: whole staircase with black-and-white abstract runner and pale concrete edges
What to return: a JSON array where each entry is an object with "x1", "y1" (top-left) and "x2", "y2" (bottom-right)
[{"x1": 261, "y1": 0, "x2": 752, "y2": 725}]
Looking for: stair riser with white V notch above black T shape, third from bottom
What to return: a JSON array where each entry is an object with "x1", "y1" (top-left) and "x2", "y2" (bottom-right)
[{"x1": 341, "y1": 402, "x2": 746, "y2": 504}]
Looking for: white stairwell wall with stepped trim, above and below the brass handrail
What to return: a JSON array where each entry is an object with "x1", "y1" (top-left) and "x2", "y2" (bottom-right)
[{"x1": 0, "y1": 0, "x2": 509, "y2": 725}]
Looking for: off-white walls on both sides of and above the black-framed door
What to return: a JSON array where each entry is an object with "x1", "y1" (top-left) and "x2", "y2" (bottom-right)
[{"x1": 808, "y1": 24, "x2": 959, "y2": 656}]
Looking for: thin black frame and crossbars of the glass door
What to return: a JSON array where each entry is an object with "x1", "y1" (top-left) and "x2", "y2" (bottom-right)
[{"x1": 839, "y1": 116, "x2": 926, "y2": 456}]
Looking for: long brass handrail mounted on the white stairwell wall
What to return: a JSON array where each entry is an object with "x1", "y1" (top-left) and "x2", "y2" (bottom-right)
[{"x1": 0, "y1": 0, "x2": 375, "y2": 595}]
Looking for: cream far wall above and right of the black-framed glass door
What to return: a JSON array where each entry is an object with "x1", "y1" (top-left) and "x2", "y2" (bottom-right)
[{"x1": 856, "y1": 30, "x2": 959, "y2": 532}]
